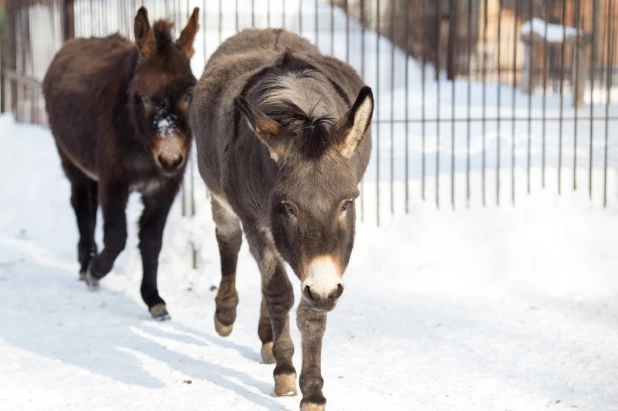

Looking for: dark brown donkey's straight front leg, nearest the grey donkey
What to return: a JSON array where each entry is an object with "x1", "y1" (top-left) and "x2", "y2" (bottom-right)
[{"x1": 139, "y1": 183, "x2": 173, "y2": 321}]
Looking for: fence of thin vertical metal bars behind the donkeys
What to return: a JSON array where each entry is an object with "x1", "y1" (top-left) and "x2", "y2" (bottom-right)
[{"x1": 0, "y1": 0, "x2": 618, "y2": 224}]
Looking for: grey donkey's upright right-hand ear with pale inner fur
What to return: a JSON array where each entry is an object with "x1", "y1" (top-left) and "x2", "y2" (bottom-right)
[{"x1": 335, "y1": 86, "x2": 373, "y2": 158}]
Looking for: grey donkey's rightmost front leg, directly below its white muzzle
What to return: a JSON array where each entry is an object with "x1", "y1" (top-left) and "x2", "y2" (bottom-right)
[{"x1": 296, "y1": 299, "x2": 326, "y2": 411}]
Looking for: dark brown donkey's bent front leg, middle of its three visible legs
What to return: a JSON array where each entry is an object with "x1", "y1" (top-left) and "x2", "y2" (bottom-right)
[{"x1": 86, "y1": 182, "x2": 129, "y2": 290}]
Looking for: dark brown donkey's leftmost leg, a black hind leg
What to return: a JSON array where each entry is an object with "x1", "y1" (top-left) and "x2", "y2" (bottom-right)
[{"x1": 60, "y1": 153, "x2": 98, "y2": 281}]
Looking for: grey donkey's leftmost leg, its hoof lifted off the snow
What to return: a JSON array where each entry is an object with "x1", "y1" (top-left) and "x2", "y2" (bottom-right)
[{"x1": 212, "y1": 197, "x2": 242, "y2": 337}]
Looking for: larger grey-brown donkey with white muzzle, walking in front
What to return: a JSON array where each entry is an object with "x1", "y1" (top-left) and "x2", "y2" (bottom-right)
[{"x1": 191, "y1": 29, "x2": 373, "y2": 410}]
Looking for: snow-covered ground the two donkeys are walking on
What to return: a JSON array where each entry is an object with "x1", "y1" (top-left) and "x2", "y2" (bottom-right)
[{"x1": 0, "y1": 116, "x2": 618, "y2": 411}]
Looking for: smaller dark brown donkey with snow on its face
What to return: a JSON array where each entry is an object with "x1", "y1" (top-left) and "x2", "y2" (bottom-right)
[{"x1": 43, "y1": 7, "x2": 199, "y2": 320}]
